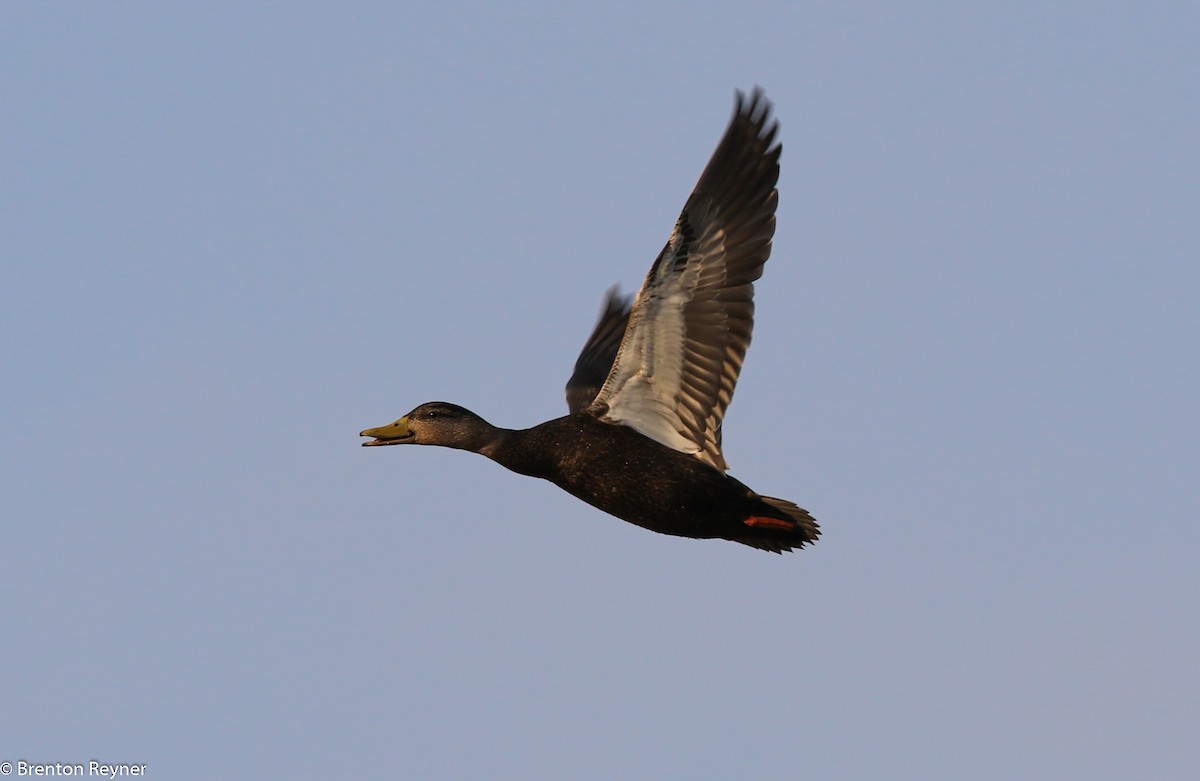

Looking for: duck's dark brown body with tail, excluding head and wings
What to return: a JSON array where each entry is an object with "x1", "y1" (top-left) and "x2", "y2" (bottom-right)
[{"x1": 482, "y1": 413, "x2": 817, "y2": 551}]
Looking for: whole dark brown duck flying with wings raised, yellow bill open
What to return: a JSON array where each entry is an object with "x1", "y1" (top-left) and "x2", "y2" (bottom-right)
[{"x1": 360, "y1": 88, "x2": 820, "y2": 553}]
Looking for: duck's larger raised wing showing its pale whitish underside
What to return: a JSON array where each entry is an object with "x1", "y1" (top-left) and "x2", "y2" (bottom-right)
[{"x1": 588, "y1": 89, "x2": 781, "y2": 471}]
